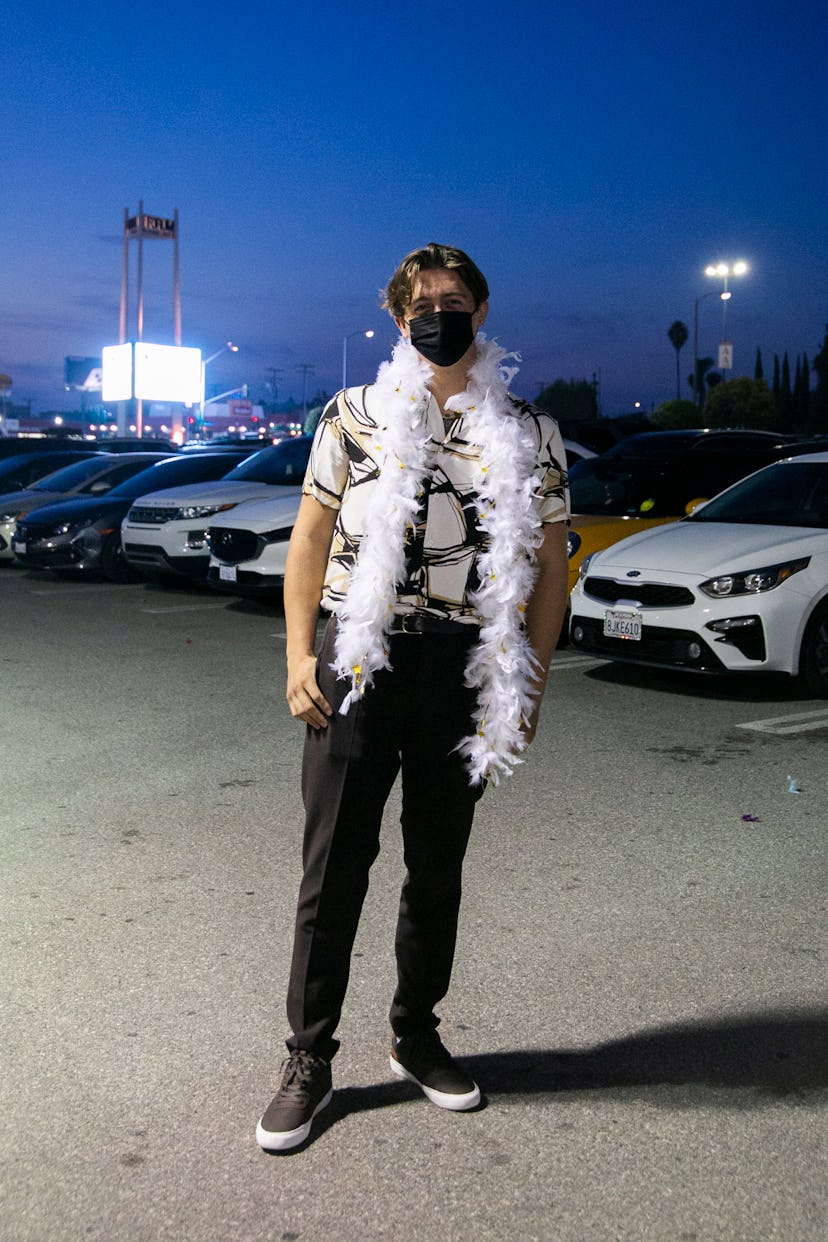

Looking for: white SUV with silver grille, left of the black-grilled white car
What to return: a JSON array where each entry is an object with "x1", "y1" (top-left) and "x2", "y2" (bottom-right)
[{"x1": 120, "y1": 436, "x2": 313, "y2": 579}]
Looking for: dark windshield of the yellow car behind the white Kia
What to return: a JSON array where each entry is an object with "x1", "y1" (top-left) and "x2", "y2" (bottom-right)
[{"x1": 569, "y1": 457, "x2": 721, "y2": 518}]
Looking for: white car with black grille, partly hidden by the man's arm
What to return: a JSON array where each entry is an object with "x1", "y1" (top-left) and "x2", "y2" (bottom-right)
[{"x1": 207, "y1": 493, "x2": 302, "y2": 599}]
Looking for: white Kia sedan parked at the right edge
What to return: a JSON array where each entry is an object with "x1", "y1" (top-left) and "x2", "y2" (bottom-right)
[{"x1": 570, "y1": 452, "x2": 828, "y2": 697}]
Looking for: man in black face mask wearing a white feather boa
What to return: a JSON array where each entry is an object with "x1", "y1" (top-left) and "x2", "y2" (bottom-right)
[{"x1": 256, "y1": 243, "x2": 569, "y2": 1150}]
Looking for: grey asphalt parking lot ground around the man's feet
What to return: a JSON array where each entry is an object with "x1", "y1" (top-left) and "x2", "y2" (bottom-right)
[{"x1": 0, "y1": 568, "x2": 828, "y2": 1242}]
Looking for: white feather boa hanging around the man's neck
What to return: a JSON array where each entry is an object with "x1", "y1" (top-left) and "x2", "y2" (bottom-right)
[{"x1": 331, "y1": 334, "x2": 541, "y2": 785}]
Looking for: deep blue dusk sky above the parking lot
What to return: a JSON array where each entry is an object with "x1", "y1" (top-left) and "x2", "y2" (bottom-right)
[{"x1": 0, "y1": 0, "x2": 828, "y2": 415}]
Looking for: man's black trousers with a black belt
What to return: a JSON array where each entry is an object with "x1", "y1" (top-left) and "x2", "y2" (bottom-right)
[{"x1": 287, "y1": 619, "x2": 482, "y2": 1058}]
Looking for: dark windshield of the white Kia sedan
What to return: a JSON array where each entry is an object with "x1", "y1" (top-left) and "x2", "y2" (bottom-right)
[{"x1": 685, "y1": 462, "x2": 828, "y2": 530}]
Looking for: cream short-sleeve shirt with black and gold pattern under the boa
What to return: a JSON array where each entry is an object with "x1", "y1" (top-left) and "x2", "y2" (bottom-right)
[{"x1": 303, "y1": 385, "x2": 569, "y2": 625}]
